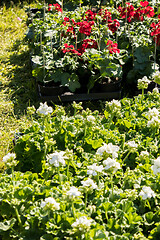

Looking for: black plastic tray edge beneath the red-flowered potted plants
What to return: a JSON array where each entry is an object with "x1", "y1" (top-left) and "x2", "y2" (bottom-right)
[{"x1": 38, "y1": 85, "x2": 122, "y2": 102}]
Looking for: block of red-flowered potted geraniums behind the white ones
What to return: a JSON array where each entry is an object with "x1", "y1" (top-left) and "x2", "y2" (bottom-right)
[{"x1": 26, "y1": 1, "x2": 160, "y2": 95}]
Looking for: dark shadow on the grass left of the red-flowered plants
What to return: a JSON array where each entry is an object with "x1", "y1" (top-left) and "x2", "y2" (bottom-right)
[{"x1": 2, "y1": 39, "x2": 38, "y2": 115}]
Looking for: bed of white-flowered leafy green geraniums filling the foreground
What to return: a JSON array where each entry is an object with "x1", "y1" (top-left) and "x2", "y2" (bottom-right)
[{"x1": 0, "y1": 89, "x2": 160, "y2": 240}]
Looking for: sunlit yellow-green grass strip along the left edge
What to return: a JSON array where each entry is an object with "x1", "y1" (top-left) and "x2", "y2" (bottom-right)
[{"x1": 0, "y1": 3, "x2": 38, "y2": 170}]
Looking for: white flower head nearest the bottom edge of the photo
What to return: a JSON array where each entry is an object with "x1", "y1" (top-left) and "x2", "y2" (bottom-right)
[{"x1": 72, "y1": 216, "x2": 93, "y2": 232}]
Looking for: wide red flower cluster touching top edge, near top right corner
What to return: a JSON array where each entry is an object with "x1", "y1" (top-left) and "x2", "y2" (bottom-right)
[{"x1": 118, "y1": 1, "x2": 155, "y2": 22}]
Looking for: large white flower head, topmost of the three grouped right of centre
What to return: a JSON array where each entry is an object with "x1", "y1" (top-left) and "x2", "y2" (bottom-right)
[{"x1": 96, "y1": 143, "x2": 119, "y2": 158}]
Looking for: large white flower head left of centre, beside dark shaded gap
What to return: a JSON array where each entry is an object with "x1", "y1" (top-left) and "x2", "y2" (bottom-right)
[{"x1": 47, "y1": 151, "x2": 65, "y2": 167}]
